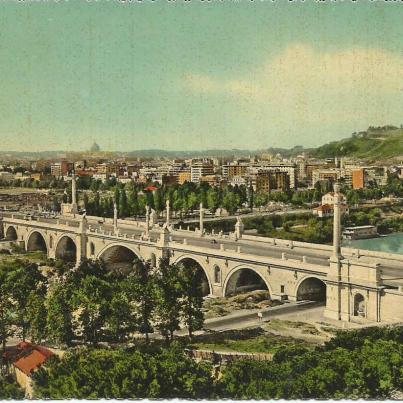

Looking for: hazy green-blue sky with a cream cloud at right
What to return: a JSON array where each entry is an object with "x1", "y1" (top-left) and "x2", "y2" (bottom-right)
[{"x1": 0, "y1": 0, "x2": 403, "y2": 151}]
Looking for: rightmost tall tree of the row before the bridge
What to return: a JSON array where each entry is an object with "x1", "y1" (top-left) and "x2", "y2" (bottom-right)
[{"x1": 179, "y1": 262, "x2": 204, "y2": 338}]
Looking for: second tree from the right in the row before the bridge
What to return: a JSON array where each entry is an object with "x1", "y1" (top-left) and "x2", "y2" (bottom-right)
[{"x1": 155, "y1": 259, "x2": 182, "y2": 343}]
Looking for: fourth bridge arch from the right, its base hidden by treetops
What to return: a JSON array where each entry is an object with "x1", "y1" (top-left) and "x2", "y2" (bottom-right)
[{"x1": 97, "y1": 243, "x2": 142, "y2": 273}]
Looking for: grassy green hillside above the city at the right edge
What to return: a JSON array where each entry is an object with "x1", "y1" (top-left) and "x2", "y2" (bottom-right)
[{"x1": 311, "y1": 126, "x2": 403, "y2": 160}]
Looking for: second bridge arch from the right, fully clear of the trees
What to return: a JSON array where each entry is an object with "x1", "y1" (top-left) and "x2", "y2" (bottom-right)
[{"x1": 223, "y1": 265, "x2": 273, "y2": 297}]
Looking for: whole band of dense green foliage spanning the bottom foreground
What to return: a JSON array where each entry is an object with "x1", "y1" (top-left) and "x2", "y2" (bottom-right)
[{"x1": 30, "y1": 327, "x2": 403, "y2": 399}]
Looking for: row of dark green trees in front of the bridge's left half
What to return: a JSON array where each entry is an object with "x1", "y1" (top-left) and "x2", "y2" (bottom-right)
[{"x1": 0, "y1": 259, "x2": 204, "y2": 350}]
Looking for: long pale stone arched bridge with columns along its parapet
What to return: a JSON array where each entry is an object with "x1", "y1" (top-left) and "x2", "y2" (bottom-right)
[{"x1": 0, "y1": 182, "x2": 403, "y2": 323}]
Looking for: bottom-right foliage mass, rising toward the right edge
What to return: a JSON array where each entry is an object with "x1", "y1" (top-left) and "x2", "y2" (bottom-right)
[{"x1": 217, "y1": 327, "x2": 403, "y2": 399}]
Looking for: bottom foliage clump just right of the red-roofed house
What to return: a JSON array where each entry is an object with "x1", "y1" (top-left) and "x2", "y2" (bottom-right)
[{"x1": 34, "y1": 345, "x2": 214, "y2": 399}]
